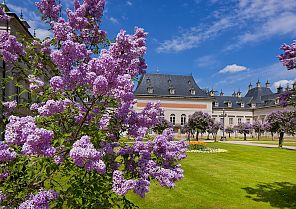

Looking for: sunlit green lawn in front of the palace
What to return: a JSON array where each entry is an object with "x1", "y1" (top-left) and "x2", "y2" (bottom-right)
[{"x1": 128, "y1": 143, "x2": 296, "y2": 209}]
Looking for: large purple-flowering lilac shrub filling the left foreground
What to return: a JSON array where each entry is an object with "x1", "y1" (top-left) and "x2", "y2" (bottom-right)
[{"x1": 0, "y1": 0, "x2": 187, "y2": 209}]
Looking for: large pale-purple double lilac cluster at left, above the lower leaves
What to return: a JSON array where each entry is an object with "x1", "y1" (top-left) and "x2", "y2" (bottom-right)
[{"x1": 5, "y1": 116, "x2": 55, "y2": 156}]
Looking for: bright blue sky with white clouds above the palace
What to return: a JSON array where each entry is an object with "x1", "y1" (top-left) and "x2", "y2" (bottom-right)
[{"x1": 6, "y1": 0, "x2": 296, "y2": 94}]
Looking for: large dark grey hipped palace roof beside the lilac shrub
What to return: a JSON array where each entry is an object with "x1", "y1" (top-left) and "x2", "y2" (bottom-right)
[{"x1": 135, "y1": 74, "x2": 208, "y2": 97}]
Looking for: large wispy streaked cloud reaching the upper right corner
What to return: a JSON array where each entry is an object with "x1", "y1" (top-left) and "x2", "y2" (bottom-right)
[{"x1": 157, "y1": 0, "x2": 296, "y2": 53}]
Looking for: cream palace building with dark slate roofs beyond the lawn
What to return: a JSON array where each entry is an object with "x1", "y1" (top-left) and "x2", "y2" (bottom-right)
[{"x1": 135, "y1": 74, "x2": 296, "y2": 132}]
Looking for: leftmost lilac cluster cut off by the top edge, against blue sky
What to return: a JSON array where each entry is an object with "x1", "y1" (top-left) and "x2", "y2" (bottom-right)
[{"x1": 36, "y1": 0, "x2": 62, "y2": 20}]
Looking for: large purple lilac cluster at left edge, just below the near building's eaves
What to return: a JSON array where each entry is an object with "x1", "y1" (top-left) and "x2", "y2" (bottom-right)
[{"x1": 0, "y1": 32, "x2": 24, "y2": 62}]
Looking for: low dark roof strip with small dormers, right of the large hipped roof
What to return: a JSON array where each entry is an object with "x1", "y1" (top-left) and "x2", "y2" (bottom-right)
[{"x1": 213, "y1": 96, "x2": 252, "y2": 109}]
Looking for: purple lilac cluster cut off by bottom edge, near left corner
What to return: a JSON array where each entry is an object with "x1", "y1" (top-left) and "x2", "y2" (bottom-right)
[{"x1": 18, "y1": 189, "x2": 59, "y2": 209}]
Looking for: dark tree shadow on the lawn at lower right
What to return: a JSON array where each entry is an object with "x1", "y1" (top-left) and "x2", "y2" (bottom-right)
[{"x1": 242, "y1": 182, "x2": 296, "y2": 209}]
